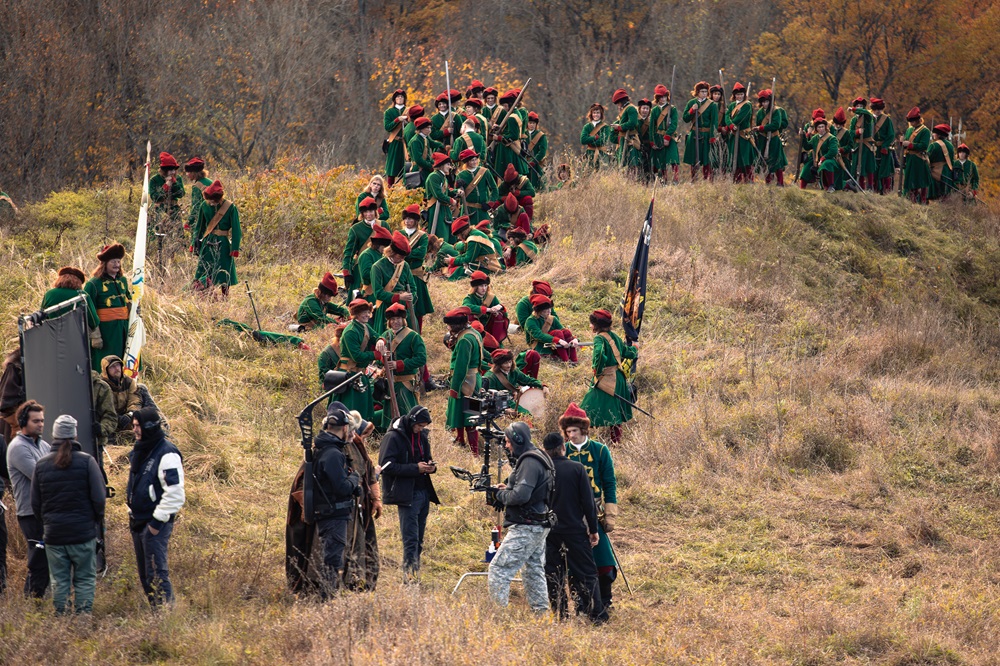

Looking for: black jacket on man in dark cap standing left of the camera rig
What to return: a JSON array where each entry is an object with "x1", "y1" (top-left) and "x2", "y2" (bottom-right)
[{"x1": 378, "y1": 416, "x2": 440, "y2": 506}]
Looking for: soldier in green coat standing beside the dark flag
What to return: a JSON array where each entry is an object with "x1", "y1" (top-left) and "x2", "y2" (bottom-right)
[{"x1": 580, "y1": 306, "x2": 636, "y2": 444}]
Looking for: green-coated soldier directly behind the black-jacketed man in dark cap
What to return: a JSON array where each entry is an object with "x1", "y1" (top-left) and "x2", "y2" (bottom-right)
[{"x1": 374, "y1": 303, "x2": 427, "y2": 432}]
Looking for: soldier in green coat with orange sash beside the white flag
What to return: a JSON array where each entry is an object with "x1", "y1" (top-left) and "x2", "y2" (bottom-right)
[{"x1": 83, "y1": 243, "x2": 132, "y2": 368}]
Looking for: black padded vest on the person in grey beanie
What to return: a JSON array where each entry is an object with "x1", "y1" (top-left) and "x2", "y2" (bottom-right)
[{"x1": 31, "y1": 443, "x2": 106, "y2": 546}]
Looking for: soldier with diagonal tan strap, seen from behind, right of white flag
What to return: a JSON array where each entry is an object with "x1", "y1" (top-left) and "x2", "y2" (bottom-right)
[{"x1": 193, "y1": 180, "x2": 243, "y2": 297}]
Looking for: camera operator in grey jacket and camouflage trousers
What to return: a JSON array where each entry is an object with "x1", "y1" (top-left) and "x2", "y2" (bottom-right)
[{"x1": 488, "y1": 421, "x2": 555, "y2": 613}]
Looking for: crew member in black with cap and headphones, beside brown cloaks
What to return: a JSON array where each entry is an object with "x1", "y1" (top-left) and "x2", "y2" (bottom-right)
[{"x1": 313, "y1": 404, "x2": 361, "y2": 597}]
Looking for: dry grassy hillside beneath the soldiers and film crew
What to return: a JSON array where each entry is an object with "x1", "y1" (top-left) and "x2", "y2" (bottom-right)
[{"x1": 0, "y1": 172, "x2": 1000, "y2": 665}]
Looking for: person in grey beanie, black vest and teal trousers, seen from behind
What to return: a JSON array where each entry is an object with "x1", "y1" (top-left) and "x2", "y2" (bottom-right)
[{"x1": 31, "y1": 414, "x2": 107, "y2": 615}]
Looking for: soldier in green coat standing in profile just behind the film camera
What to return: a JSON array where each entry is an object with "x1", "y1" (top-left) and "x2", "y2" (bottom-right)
[{"x1": 444, "y1": 308, "x2": 483, "y2": 455}]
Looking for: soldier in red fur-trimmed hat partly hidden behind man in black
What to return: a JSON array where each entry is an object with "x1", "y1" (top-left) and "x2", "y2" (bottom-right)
[{"x1": 559, "y1": 402, "x2": 618, "y2": 609}]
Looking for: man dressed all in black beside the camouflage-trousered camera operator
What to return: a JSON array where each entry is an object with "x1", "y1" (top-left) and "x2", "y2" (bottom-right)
[{"x1": 542, "y1": 432, "x2": 608, "y2": 624}]
